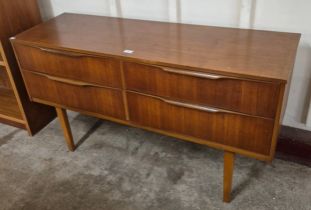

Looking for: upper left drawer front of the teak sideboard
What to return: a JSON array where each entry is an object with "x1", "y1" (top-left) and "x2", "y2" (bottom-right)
[{"x1": 15, "y1": 44, "x2": 122, "y2": 88}]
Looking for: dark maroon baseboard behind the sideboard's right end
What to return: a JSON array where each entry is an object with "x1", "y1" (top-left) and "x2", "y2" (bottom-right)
[{"x1": 276, "y1": 126, "x2": 311, "y2": 167}]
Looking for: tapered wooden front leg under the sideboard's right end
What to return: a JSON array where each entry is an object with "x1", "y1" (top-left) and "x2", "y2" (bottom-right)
[{"x1": 223, "y1": 151, "x2": 235, "y2": 203}]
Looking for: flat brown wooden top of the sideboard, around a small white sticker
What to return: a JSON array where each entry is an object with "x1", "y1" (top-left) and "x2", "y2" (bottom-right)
[{"x1": 15, "y1": 13, "x2": 300, "y2": 82}]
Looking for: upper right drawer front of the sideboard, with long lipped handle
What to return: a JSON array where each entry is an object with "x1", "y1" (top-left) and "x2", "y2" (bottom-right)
[{"x1": 124, "y1": 62, "x2": 279, "y2": 118}]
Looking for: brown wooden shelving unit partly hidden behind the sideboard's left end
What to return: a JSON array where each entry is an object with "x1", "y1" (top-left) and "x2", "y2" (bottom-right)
[{"x1": 0, "y1": 0, "x2": 56, "y2": 135}]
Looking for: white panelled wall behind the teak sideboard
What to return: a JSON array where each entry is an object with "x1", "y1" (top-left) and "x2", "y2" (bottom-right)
[{"x1": 39, "y1": 0, "x2": 311, "y2": 130}]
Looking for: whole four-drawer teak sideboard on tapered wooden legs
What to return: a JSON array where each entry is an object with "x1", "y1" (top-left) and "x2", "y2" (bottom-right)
[{"x1": 11, "y1": 14, "x2": 300, "y2": 202}]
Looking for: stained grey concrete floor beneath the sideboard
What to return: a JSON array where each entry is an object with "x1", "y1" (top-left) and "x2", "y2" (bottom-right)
[{"x1": 0, "y1": 113, "x2": 311, "y2": 210}]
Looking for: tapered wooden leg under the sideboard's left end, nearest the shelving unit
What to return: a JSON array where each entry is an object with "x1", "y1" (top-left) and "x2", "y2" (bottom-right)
[{"x1": 56, "y1": 107, "x2": 75, "y2": 151}]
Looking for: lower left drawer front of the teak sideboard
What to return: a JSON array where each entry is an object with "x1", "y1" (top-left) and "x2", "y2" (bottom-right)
[{"x1": 23, "y1": 71, "x2": 125, "y2": 119}]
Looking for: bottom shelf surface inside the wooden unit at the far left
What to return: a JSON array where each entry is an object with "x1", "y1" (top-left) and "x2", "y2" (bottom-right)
[{"x1": 0, "y1": 88, "x2": 24, "y2": 123}]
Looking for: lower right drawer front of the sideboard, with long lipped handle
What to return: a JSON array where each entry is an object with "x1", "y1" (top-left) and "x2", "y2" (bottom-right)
[{"x1": 127, "y1": 92, "x2": 273, "y2": 155}]
